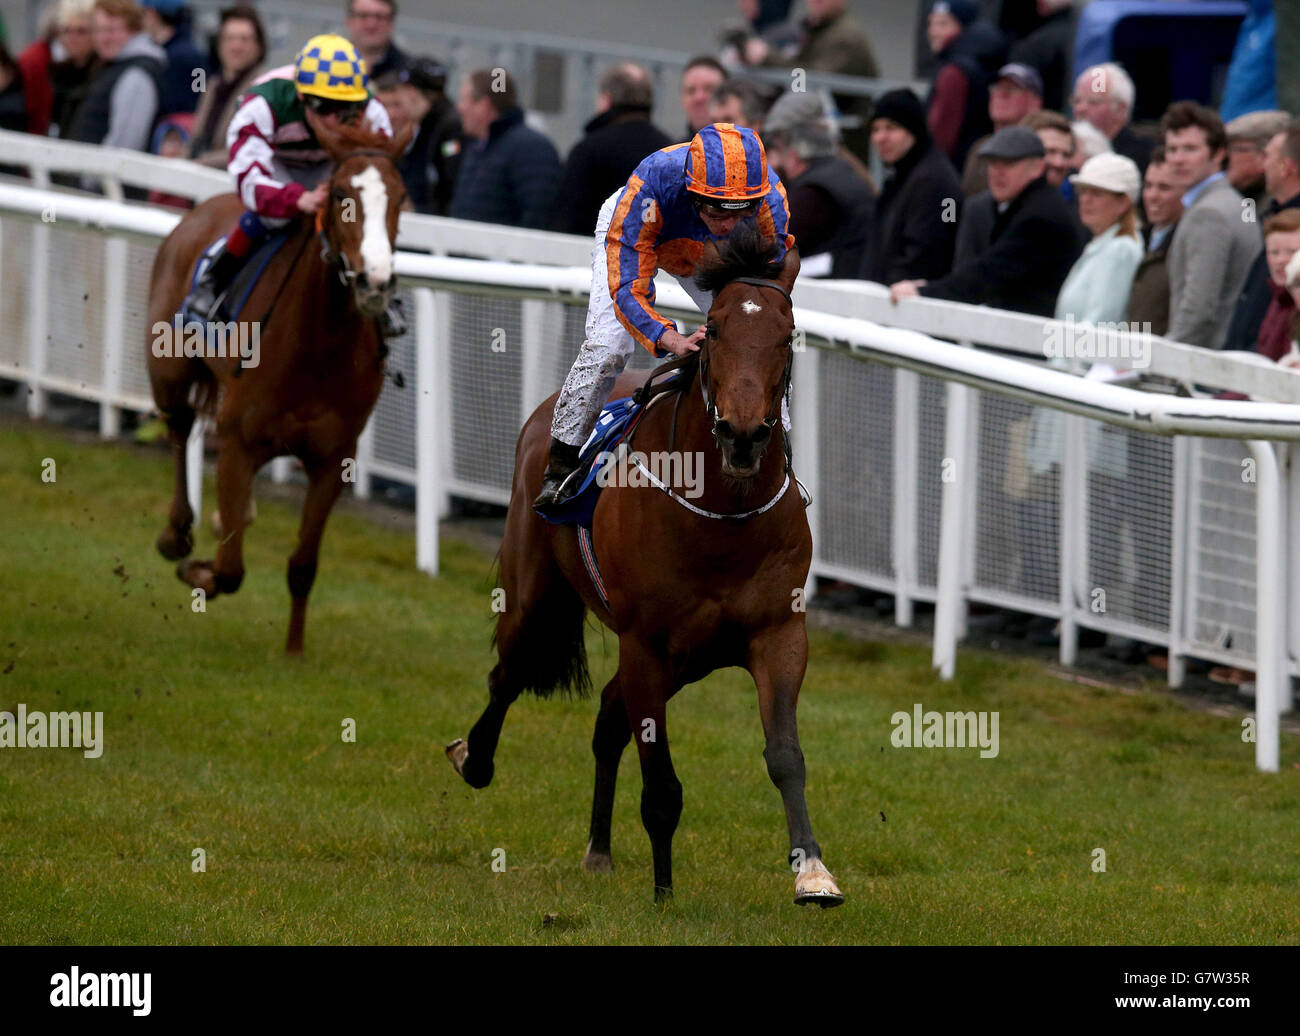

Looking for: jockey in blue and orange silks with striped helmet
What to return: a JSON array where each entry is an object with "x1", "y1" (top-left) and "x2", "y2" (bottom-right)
[{"x1": 533, "y1": 122, "x2": 794, "y2": 507}]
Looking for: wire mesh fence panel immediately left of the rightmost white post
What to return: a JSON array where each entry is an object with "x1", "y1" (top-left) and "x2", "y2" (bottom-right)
[{"x1": 1187, "y1": 439, "x2": 1258, "y2": 664}]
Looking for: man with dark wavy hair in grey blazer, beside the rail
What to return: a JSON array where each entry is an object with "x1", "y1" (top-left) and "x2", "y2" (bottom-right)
[{"x1": 1161, "y1": 101, "x2": 1262, "y2": 348}]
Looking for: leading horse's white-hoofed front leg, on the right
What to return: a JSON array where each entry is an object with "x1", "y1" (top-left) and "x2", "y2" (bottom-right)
[{"x1": 746, "y1": 615, "x2": 844, "y2": 906}]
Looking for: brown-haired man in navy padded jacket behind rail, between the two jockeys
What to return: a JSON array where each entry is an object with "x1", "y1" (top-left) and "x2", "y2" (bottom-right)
[{"x1": 447, "y1": 69, "x2": 560, "y2": 230}]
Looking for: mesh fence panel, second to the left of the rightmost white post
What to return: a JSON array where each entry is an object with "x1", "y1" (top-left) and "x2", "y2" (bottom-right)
[{"x1": 1080, "y1": 421, "x2": 1174, "y2": 642}]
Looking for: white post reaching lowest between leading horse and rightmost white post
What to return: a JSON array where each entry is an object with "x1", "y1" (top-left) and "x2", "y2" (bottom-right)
[{"x1": 932, "y1": 381, "x2": 971, "y2": 680}]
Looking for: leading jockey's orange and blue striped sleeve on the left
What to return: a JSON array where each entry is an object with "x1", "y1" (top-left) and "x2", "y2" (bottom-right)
[{"x1": 605, "y1": 173, "x2": 675, "y2": 352}]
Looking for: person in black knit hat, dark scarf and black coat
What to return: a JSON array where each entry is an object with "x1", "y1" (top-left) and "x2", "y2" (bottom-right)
[{"x1": 862, "y1": 90, "x2": 962, "y2": 285}]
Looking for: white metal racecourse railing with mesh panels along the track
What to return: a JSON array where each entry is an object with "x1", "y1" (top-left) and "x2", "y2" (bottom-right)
[{"x1": 0, "y1": 135, "x2": 1300, "y2": 770}]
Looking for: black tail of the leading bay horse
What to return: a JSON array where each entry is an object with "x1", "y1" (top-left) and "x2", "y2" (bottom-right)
[{"x1": 491, "y1": 553, "x2": 592, "y2": 698}]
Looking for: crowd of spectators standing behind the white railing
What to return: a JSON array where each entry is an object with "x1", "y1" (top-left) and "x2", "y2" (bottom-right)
[{"x1": 0, "y1": 0, "x2": 1300, "y2": 665}]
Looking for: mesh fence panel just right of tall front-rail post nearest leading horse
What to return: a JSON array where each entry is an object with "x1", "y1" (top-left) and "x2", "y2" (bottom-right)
[{"x1": 971, "y1": 393, "x2": 1061, "y2": 611}]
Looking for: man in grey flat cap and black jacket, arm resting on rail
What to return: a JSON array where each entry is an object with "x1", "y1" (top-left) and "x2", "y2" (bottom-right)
[{"x1": 889, "y1": 126, "x2": 1083, "y2": 317}]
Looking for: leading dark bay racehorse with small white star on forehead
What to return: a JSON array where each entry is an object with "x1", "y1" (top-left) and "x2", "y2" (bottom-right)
[{"x1": 447, "y1": 222, "x2": 844, "y2": 906}]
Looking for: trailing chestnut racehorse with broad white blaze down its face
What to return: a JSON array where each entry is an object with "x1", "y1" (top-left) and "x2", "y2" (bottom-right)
[{"x1": 147, "y1": 112, "x2": 410, "y2": 654}]
